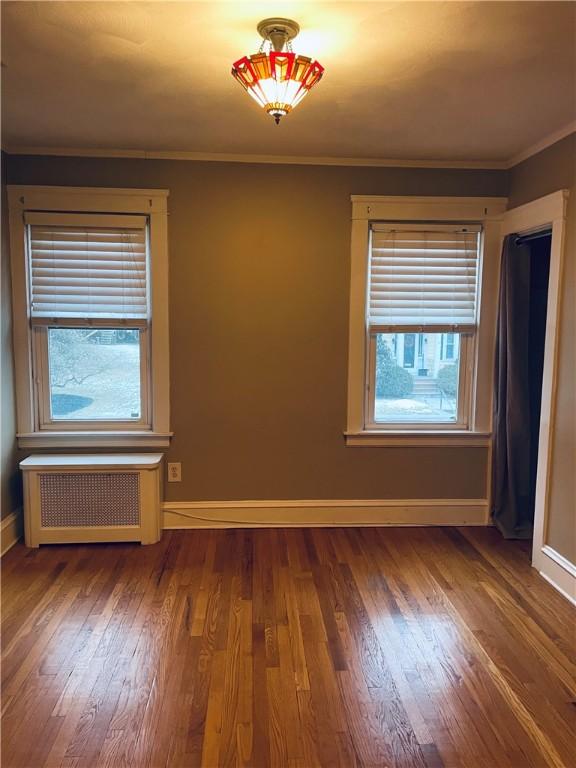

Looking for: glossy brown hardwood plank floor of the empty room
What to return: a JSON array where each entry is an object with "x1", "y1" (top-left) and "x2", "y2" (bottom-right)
[{"x1": 2, "y1": 528, "x2": 576, "y2": 768}]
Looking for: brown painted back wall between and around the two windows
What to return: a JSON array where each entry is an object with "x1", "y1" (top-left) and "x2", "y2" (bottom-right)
[{"x1": 9, "y1": 156, "x2": 508, "y2": 500}]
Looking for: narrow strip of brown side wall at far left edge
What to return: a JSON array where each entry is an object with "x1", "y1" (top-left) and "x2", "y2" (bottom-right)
[{"x1": 0, "y1": 153, "x2": 22, "y2": 520}]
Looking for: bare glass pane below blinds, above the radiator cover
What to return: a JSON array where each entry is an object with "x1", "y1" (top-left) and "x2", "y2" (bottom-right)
[{"x1": 48, "y1": 328, "x2": 141, "y2": 421}]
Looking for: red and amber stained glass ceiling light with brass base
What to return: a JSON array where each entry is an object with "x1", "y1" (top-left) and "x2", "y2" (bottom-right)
[{"x1": 232, "y1": 19, "x2": 324, "y2": 124}]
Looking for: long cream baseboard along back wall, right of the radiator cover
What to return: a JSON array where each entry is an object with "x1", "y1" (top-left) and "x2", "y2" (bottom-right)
[{"x1": 163, "y1": 499, "x2": 488, "y2": 529}]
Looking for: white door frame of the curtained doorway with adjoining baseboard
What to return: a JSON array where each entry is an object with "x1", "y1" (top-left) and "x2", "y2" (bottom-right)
[{"x1": 498, "y1": 189, "x2": 576, "y2": 603}]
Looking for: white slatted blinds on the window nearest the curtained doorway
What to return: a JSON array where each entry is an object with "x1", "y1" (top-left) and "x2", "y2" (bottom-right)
[{"x1": 368, "y1": 223, "x2": 481, "y2": 332}]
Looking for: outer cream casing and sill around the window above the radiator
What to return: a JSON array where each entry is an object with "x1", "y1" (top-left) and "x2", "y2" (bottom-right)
[{"x1": 8, "y1": 185, "x2": 171, "y2": 448}]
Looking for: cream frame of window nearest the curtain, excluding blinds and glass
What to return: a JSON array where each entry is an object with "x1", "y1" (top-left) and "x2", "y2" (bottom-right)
[{"x1": 345, "y1": 195, "x2": 508, "y2": 447}]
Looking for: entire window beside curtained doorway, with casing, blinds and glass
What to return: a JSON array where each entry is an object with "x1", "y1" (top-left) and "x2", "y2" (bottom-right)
[{"x1": 346, "y1": 197, "x2": 505, "y2": 445}]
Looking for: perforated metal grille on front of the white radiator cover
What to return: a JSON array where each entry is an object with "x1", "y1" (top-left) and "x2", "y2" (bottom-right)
[{"x1": 39, "y1": 472, "x2": 140, "y2": 528}]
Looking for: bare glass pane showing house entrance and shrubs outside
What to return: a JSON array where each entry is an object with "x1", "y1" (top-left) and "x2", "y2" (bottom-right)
[{"x1": 374, "y1": 333, "x2": 460, "y2": 424}]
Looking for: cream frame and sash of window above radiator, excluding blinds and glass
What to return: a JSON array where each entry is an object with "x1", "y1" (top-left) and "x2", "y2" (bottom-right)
[{"x1": 8, "y1": 185, "x2": 172, "y2": 448}]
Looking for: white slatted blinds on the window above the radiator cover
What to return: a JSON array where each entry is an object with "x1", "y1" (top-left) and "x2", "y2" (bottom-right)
[{"x1": 27, "y1": 214, "x2": 148, "y2": 320}]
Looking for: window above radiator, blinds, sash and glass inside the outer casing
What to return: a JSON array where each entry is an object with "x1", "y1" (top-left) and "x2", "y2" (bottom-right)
[{"x1": 25, "y1": 213, "x2": 150, "y2": 429}]
